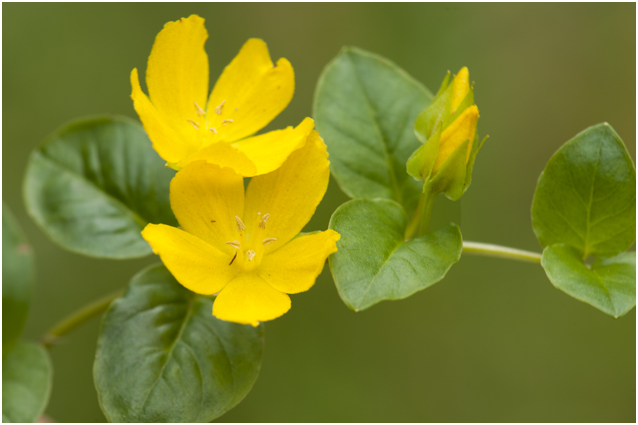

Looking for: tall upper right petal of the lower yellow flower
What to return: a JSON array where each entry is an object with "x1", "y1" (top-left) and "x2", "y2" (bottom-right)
[{"x1": 244, "y1": 131, "x2": 330, "y2": 248}]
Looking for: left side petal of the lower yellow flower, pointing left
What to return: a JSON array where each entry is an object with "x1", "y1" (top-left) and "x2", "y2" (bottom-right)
[{"x1": 142, "y1": 224, "x2": 239, "y2": 295}]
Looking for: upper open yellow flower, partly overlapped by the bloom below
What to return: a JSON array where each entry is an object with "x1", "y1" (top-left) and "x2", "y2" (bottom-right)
[{"x1": 131, "y1": 15, "x2": 314, "y2": 176}]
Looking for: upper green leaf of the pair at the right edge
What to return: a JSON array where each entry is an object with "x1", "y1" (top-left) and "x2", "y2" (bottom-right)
[{"x1": 532, "y1": 123, "x2": 636, "y2": 258}]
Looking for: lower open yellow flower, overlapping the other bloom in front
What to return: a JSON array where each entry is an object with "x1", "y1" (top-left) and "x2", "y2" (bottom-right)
[{"x1": 142, "y1": 131, "x2": 339, "y2": 325}]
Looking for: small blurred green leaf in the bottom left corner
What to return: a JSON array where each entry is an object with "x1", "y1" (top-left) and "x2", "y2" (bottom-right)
[{"x1": 2, "y1": 342, "x2": 53, "y2": 422}]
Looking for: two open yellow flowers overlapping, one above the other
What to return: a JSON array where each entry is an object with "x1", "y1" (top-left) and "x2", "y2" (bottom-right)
[{"x1": 131, "y1": 15, "x2": 339, "y2": 325}]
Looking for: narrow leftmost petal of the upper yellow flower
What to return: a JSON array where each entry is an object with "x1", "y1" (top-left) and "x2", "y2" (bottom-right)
[{"x1": 131, "y1": 69, "x2": 200, "y2": 163}]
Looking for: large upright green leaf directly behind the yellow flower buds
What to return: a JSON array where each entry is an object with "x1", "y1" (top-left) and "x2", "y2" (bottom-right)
[{"x1": 314, "y1": 47, "x2": 432, "y2": 215}]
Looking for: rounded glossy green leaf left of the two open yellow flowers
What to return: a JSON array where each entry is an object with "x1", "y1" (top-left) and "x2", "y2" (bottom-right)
[{"x1": 24, "y1": 117, "x2": 177, "y2": 258}]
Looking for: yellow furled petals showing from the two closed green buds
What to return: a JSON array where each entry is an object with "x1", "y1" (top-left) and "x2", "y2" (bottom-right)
[{"x1": 432, "y1": 67, "x2": 479, "y2": 173}]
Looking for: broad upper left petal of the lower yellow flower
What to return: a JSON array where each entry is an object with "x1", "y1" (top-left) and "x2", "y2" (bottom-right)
[{"x1": 170, "y1": 161, "x2": 244, "y2": 255}]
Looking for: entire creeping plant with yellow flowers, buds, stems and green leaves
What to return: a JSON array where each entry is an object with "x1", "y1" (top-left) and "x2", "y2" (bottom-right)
[{"x1": 2, "y1": 15, "x2": 636, "y2": 422}]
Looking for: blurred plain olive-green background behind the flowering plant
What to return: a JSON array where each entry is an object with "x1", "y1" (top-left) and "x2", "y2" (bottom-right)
[{"x1": 2, "y1": 3, "x2": 636, "y2": 422}]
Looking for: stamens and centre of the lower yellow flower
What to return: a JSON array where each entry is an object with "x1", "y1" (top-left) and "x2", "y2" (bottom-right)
[{"x1": 226, "y1": 212, "x2": 277, "y2": 270}]
